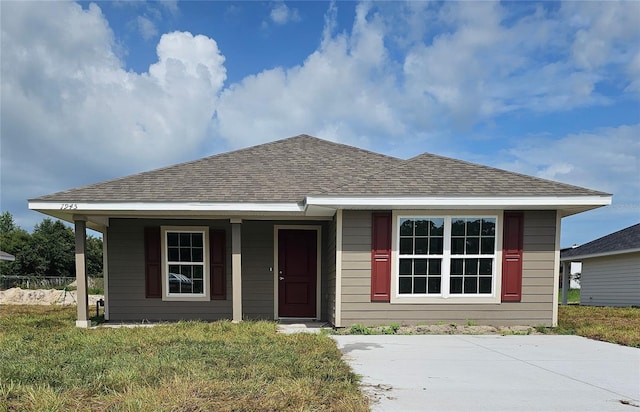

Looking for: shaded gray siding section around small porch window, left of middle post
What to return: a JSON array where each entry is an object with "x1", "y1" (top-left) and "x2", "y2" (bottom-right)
[{"x1": 107, "y1": 219, "x2": 231, "y2": 322}]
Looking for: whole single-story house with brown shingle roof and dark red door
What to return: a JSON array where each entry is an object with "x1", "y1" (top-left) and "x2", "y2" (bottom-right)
[{"x1": 29, "y1": 135, "x2": 611, "y2": 327}]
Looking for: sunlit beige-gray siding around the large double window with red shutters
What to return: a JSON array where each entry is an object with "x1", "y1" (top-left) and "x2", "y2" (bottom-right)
[{"x1": 341, "y1": 211, "x2": 556, "y2": 326}]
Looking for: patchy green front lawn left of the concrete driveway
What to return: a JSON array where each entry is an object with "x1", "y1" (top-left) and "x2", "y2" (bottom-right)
[{"x1": 0, "y1": 306, "x2": 368, "y2": 411}]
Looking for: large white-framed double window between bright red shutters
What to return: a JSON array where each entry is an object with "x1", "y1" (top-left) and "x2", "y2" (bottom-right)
[{"x1": 391, "y1": 211, "x2": 502, "y2": 303}]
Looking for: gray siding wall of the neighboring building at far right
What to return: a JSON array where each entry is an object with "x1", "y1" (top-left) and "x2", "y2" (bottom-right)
[{"x1": 580, "y1": 252, "x2": 640, "y2": 306}]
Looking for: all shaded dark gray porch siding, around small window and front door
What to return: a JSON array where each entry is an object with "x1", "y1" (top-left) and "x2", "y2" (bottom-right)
[{"x1": 107, "y1": 219, "x2": 328, "y2": 322}]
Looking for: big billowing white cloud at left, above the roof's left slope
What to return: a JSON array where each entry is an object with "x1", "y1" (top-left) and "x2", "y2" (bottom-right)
[{"x1": 0, "y1": 2, "x2": 226, "y2": 225}]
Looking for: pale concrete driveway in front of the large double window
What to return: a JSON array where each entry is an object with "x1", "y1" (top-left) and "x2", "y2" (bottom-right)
[{"x1": 333, "y1": 335, "x2": 640, "y2": 412}]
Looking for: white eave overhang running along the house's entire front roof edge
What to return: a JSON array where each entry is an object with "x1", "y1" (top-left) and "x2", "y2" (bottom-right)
[{"x1": 29, "y1": 195, "x2": 611, "y2": 231}]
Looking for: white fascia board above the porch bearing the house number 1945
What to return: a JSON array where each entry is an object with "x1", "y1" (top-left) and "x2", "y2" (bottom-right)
[{"x1": 29, "y1": 201, "x2": 305, "y2": 213}]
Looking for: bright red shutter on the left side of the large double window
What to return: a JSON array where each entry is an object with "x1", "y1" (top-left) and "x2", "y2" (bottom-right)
[{"x1": 371, "y1": 212, "x2": 391, "y2": 302}]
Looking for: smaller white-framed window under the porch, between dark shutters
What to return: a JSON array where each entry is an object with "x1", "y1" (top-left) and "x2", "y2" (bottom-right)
[{"x1": 161, "y1": 226, "x2": 210, "y2": 301}]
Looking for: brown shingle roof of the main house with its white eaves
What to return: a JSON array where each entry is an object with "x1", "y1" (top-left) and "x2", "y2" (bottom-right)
[{"x1": 29, "y1": 135, "x2": 611, "y2": 229}]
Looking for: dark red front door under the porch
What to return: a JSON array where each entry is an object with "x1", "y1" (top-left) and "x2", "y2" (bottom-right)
[{"x1": 278, "y1": 229, "x2": 318, "y2": 318}]
